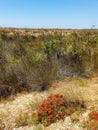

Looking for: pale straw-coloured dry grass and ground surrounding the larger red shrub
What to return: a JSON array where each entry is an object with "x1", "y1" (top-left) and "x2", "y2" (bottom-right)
[{"x1": 0, "y1": 77, "x2": 98, "y2": 130}]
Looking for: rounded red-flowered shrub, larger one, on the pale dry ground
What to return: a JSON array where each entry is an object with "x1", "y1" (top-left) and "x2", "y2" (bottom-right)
[{"x1": 37, "y1": 94, "x2": 74, "y2": 125}]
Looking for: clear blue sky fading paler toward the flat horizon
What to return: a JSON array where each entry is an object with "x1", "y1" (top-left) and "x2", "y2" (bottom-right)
[{"x1": 0, "y1": 0, "x2": 98, "y2": 29}]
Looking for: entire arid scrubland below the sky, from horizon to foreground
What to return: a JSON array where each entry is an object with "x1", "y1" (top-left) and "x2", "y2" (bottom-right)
[{"x1": 0, "y1": 28, "x2": 98, "y2": 130}]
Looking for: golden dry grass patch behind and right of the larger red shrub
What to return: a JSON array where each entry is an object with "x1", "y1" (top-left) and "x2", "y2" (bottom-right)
[{"x1": 50, "y1": 77, "x2": 98, "y2": 107}]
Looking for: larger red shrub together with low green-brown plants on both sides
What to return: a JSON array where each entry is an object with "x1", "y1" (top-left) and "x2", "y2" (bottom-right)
[{"x1": 16, "y1": 94, "x2": 85, "y2": 126}]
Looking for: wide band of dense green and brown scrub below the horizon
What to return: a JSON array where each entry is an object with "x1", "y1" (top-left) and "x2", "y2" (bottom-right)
[{"x1": 0, "y1": 29, "x2": 98, "y2": 98}]
